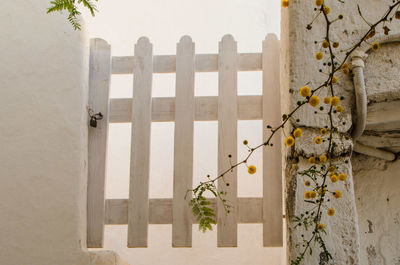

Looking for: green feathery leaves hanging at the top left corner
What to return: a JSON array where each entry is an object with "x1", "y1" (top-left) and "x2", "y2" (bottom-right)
[{"x1": 47, "y1": 0, "x2": 98, "y2": 30}]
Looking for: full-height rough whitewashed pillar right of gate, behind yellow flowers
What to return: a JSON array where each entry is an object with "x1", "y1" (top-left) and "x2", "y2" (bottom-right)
[{"x1": 281, "y1": 0, "x2": 399, "y2": 264}]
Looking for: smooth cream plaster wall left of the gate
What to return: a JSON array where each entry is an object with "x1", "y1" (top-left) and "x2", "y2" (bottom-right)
[{"x1": 0, "y1": 0, "x2": 89, "y2": 265}]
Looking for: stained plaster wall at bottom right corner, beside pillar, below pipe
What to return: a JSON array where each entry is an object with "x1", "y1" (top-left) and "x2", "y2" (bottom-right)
[{"x1": 352, "y1": 155, "x2": 400, "y2": 265}]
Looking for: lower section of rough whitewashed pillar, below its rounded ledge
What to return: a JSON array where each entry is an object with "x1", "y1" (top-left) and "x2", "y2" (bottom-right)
[{"x1": 287, "y1": 157, "x2": 359, "y2": 264}]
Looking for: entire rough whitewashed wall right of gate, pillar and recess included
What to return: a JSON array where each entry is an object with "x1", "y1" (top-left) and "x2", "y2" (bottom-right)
[{"x1": 281, "y1": 0, "x2": 400, "y2": 265}]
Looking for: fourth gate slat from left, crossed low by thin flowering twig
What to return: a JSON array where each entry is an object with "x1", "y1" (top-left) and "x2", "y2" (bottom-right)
[{"x1": 217, "y1": 35, "x2": 238, "y2": 247}]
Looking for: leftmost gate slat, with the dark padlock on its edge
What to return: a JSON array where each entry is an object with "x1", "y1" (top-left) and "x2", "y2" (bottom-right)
[{"x1": 87, "y1": 39, "x2": 111, "y2": 248}]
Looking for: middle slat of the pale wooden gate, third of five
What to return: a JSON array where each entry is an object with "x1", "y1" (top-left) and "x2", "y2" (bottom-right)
[{"x1": 172, "y1": 36, "x2": 195, "y2": 247}]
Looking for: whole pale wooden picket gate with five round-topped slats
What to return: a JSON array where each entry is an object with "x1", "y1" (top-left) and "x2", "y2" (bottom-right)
[{"x1": 87, "y1": 34, "x2": 283, "y2": 247}]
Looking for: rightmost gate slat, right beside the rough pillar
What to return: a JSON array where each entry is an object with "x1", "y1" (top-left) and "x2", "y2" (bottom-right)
[{"x1": 262, "y1": 34, "x2": 283, "y2": 247}]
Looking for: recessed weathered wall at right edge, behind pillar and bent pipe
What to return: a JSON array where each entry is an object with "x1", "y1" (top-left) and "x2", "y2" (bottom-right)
[{"x1": 352, "y1": 33, "x2": 400, "y2": 265}]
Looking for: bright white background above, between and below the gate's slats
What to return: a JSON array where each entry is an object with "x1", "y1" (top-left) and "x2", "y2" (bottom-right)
[{"x1": 84, "y1": 0, "x2": 285, "y2": 265}]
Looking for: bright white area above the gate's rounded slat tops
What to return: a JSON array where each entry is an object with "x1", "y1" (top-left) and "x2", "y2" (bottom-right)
[{"x1": 85, "y1": 0, "x2": 280, "y2": 55}]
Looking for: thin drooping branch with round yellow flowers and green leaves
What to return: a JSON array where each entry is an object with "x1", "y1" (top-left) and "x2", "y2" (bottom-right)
[{"x1": 188, "y1": 0, "x2": 400, "y2": 265}]
